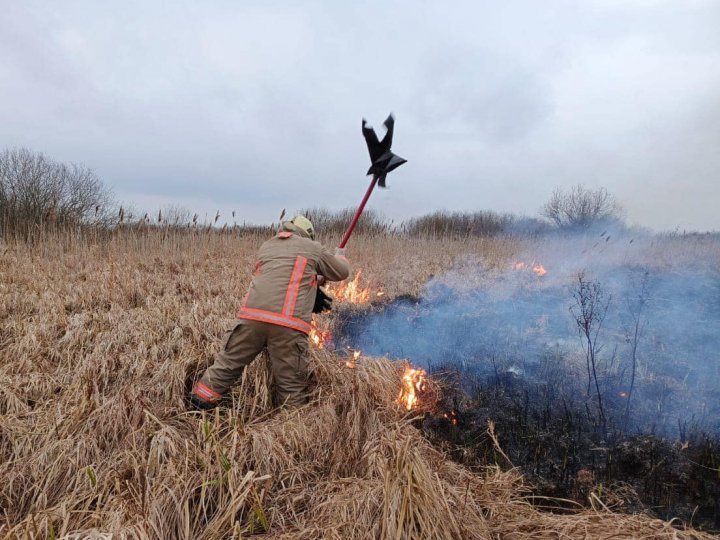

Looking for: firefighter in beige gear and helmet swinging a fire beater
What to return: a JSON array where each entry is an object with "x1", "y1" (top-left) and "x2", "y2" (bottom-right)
[{"x1": 189, "y1": 215, "x2": 350, "y2": 409}]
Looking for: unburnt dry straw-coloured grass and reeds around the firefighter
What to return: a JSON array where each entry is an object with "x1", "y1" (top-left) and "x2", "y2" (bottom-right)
[{"x1": 0, "y1": 231, "x2": 711, "y2": 539}]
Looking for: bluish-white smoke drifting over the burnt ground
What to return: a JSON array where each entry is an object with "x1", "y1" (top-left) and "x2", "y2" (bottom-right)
[{"x1": 343, "y1": 231, "x2": 720, "y2": 433}]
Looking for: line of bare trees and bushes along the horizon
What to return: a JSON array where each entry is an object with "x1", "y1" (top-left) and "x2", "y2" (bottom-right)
[{"x1": 0, "y1": 148, "x2": 623, "y2": 240}]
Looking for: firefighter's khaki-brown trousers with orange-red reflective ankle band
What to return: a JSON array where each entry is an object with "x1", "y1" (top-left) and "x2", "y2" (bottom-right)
[{"x1": 192, "y1": 319, "x2": 311, "y2": 406}]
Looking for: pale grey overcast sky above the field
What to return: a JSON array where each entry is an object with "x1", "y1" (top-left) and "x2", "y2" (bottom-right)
[{"x1": 0, "y1": 0, "x2": 720, "y2": 230}]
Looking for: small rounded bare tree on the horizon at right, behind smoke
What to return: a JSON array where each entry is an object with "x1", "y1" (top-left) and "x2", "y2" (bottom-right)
[{"x1": 541, "y1": 184, "x2": 623, "y2": 228}]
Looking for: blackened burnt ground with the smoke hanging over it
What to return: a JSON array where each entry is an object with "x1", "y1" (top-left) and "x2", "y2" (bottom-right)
[{"x1": 338, "y1": 231, "x2": 720, "y2": 531}]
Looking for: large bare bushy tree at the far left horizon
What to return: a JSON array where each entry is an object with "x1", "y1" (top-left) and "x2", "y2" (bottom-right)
[{"x1": 0, "y1": 148, "x2": 111, "y2": 237}]
